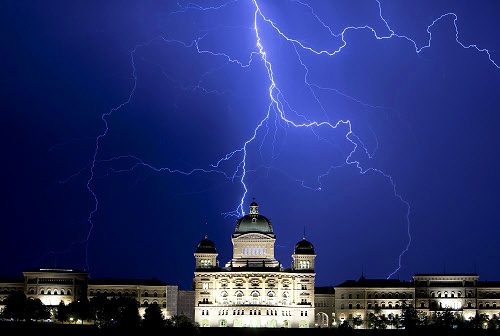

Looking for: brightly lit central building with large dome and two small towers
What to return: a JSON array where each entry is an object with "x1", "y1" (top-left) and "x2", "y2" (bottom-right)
[{"x1": 193, "y1": 202, "x2": 316, "y2": 328}]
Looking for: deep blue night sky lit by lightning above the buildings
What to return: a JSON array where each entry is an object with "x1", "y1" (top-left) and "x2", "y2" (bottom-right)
[{"x1": 0, "y1": 0, "x2": 500, "y2": 288}]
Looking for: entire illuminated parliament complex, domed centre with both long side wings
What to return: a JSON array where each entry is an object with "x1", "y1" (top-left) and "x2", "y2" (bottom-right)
[{"x1": 0, "y1": 202, "x2": 500, "y2": 328}]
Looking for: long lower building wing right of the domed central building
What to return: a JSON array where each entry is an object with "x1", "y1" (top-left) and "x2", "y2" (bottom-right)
[{"x1": 315, "y1": 274, "x2": 500, "y2": 328}]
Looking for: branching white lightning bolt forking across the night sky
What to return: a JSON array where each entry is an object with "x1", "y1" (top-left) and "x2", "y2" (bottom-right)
[{"x1": 73, "y1": 0, "x2": 500, "y2": 278}]
